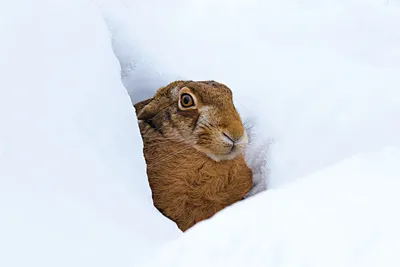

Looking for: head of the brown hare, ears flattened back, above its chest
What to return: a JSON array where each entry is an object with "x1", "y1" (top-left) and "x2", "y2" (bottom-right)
[{"x1": 135, "y1": 81, "x2": 248, "y2": 161}]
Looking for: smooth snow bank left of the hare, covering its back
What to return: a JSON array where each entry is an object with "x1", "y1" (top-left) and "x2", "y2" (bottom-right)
[{"x1": 0, "y1": 0, "x2": 178, "y2": 267}]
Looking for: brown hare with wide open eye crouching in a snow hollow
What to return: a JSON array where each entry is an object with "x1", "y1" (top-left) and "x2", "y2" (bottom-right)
[{"x1": 134, "y1": 81, "x2": 252, "y2": 232}]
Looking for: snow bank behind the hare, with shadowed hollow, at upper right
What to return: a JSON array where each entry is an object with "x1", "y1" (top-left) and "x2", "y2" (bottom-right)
[{"x1": 95, "y1": 0, "x2": 400, "y2": 191}]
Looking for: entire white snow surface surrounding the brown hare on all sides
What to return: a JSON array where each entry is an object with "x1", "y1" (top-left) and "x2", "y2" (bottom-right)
[{"x1": 0, "y1": 0, "x2": 400, "y2": 267}]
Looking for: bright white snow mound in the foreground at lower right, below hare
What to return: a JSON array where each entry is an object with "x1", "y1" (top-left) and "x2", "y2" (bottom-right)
[{"x1": 140, "y1": 148, "x2": 400, "y2": 267}]
